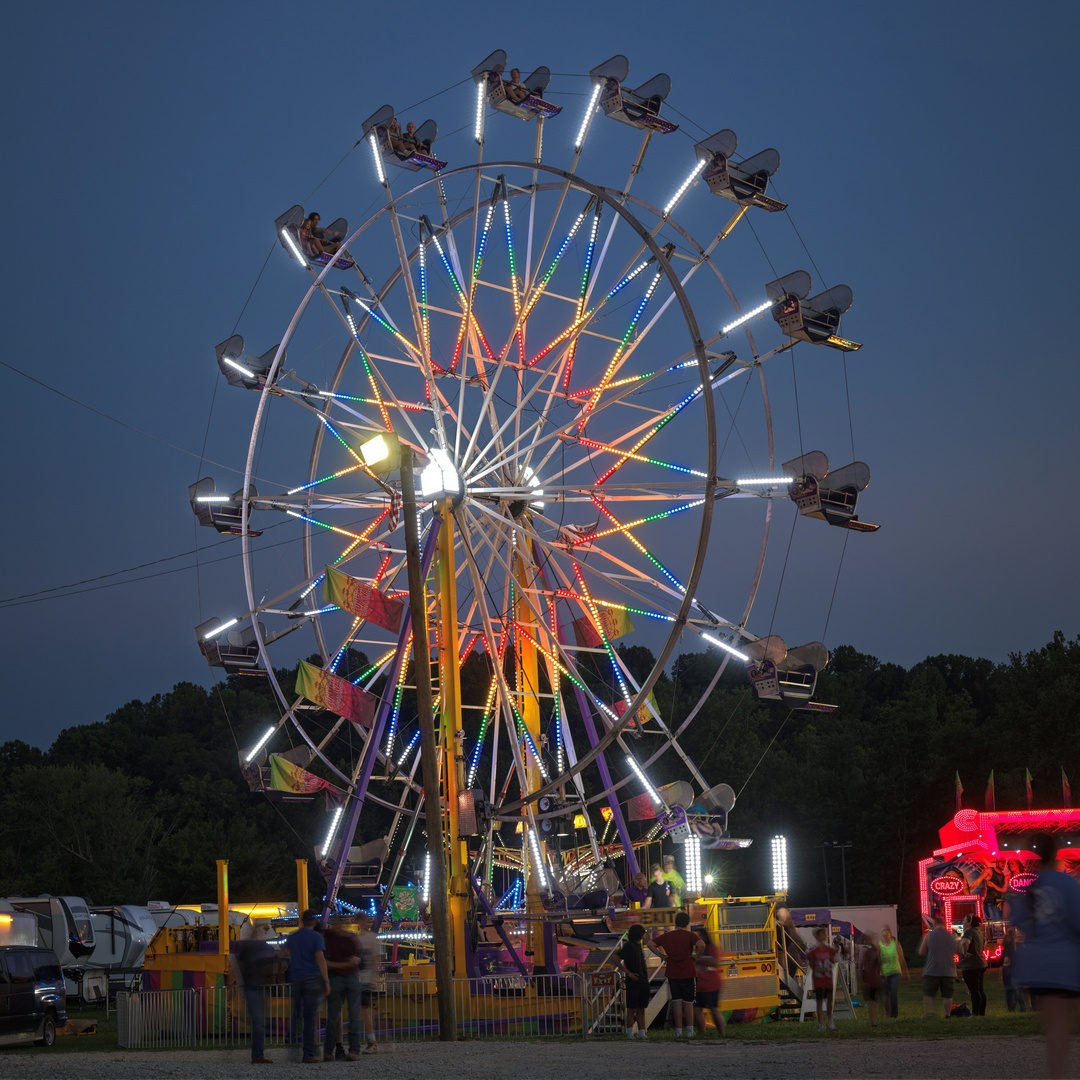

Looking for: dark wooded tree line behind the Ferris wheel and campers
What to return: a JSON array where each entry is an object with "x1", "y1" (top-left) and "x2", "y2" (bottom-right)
[{"x1": 0, "y1": 633, "x2": 1080, "y2": 946}]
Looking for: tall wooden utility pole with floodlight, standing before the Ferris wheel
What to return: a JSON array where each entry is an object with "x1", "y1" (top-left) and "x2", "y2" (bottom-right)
[{"x1": 403, "y1": 445, "x2": 458, "y2": 1042}]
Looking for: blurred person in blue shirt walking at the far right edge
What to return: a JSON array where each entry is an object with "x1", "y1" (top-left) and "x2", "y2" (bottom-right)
[{"x1": 1005, "y1": 833, "x2": 1080, "y2": 1080}]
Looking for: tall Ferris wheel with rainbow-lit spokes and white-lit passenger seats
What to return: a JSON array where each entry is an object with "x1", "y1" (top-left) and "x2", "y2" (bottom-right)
[{"x1": 190, "y1": 52, "x2": 876, "y2": 928}]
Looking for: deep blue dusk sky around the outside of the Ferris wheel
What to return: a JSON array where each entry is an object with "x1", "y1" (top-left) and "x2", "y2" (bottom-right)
[{"x1": 0, "y1": 0, "x2": 1080, "y2": 746}]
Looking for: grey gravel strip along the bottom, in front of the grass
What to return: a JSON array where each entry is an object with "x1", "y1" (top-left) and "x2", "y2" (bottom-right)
[{"x1": 0, "y1": 1036, "x2": 1062, "y2": 1080}]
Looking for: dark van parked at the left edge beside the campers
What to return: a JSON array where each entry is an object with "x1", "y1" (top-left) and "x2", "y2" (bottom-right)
[{"x1": 0, "y1": 945, "x2": 67, "y2": 1047}]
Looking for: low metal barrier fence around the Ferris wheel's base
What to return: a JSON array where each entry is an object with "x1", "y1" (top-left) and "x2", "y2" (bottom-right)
[{"x1": 117, "y1": 969, "x2": 623, "y2": 1050}]
